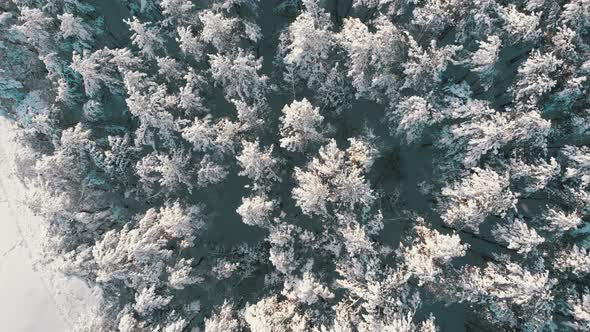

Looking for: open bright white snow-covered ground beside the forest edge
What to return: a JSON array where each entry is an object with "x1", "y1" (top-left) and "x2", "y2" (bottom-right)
[{"x1": 0, "y1": 116, "x2": 97, "y2": 332}]
